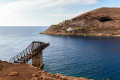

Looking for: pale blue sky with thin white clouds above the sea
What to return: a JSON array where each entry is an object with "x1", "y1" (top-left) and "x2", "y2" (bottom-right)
[{"x1": 0, "y1": 0, "x2": 120, "y2": 26}]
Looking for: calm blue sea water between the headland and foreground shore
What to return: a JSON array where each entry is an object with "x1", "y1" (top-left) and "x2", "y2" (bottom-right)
[{"x1": 0, "y1": 27, "x2": 120, "y2": 80}]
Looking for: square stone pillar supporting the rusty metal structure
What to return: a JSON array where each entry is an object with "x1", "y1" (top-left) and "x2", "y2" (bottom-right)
[{"x1": 32, "y1": 51, "x2": 44, "y2": 68}]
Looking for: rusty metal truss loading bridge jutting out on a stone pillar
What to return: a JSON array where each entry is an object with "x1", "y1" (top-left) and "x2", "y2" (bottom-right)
[{"x1": 9, "y1": 41, "x2": 50, "y2": 63}]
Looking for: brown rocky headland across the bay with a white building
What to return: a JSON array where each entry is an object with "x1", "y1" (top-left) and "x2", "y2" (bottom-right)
[{"x1": 42, "y1": 7, "x2": 120, "y2": 36}]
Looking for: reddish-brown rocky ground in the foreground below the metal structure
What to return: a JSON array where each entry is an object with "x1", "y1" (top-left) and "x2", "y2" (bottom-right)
[{"x1": 0, "y1": 61, "x2": 92, "y2": 80}]
